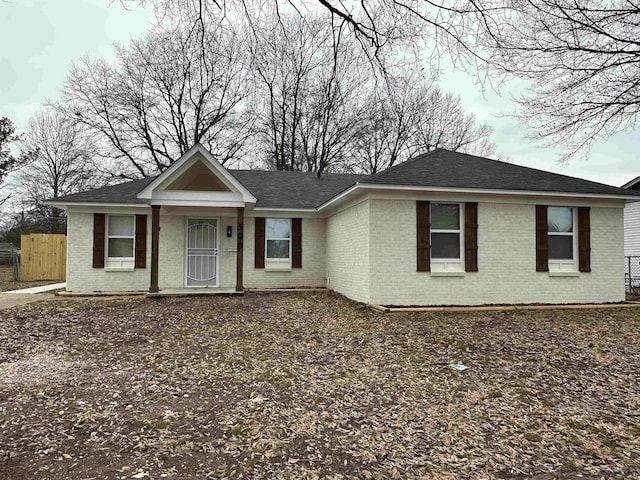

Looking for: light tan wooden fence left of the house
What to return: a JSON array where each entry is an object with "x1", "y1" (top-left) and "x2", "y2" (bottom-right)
[{"x1": 20, "y1": 233, "x2": 67, "y2": 281}]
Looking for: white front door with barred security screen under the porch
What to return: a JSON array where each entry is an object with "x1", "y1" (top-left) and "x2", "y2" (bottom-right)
[{"x1": 186, "y1": 218, "x2": 219, "y2": 287}]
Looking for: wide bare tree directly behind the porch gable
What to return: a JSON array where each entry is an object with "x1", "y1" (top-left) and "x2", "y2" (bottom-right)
[{"x1": 58, "y1": 21, "x2": 251, "y2": 178}]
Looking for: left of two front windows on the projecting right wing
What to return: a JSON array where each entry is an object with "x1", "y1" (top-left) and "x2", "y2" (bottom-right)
[{"x1": 431, "y1": 203, "x2": 462, "y2": 261}]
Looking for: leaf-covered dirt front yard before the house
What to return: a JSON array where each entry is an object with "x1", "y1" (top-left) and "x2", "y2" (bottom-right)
[{"x1": 0, "y1": 292, "x2": 640, "y2": 480}]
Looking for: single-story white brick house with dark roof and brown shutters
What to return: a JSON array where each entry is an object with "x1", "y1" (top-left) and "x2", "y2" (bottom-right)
[{"x1": 49, "y1": 145, "x2": 640, "y2": 305}]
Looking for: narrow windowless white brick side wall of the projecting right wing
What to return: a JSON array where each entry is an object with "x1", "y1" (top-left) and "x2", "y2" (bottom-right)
[{"x1": 327, "y1": 200, "x2": 375, "y2": 303}]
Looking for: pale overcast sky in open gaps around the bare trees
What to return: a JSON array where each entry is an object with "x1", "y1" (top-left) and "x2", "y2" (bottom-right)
[{"x1": 0, "y1": 0, "x2": 640, "y2": 186}]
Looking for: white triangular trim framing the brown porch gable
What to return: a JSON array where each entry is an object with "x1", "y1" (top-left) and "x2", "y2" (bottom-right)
[{"x1": 137, "y1": 143, "x2": 258, "y2": 207}]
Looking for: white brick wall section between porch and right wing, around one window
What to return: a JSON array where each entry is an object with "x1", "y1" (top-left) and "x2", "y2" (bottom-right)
[{"x1": 244, "y1": 215, "x2": 326, "y2": 288}]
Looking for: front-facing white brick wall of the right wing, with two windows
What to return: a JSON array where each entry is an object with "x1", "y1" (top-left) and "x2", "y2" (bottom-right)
[{"x1": 370, "y1": 200, "x2": 624, "y2": 305}]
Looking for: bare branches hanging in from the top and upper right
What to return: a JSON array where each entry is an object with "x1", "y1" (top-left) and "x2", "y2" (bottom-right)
[{"x1": 121, "y1": 0, "x2": 640, "y2": 160}]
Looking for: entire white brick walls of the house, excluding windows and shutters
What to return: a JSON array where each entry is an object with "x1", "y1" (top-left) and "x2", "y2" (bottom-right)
[{"x1": 67, "y1": 199, "x2": 624, "y2": 305}]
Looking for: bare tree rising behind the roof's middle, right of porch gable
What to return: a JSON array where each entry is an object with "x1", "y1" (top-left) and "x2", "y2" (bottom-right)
[{"x1": 252, "y1": 16, "x2": 366, "y2": 172}]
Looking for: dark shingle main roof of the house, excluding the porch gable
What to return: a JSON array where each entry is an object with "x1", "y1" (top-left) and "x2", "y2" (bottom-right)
[{"x1": 56, "y1": 150, "x2": 640, "y2": 209}]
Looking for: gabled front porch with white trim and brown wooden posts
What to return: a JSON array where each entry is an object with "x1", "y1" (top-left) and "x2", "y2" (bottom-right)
[{"x1": 137, "y1": 144, "x2": 257, "y2": 293}]
